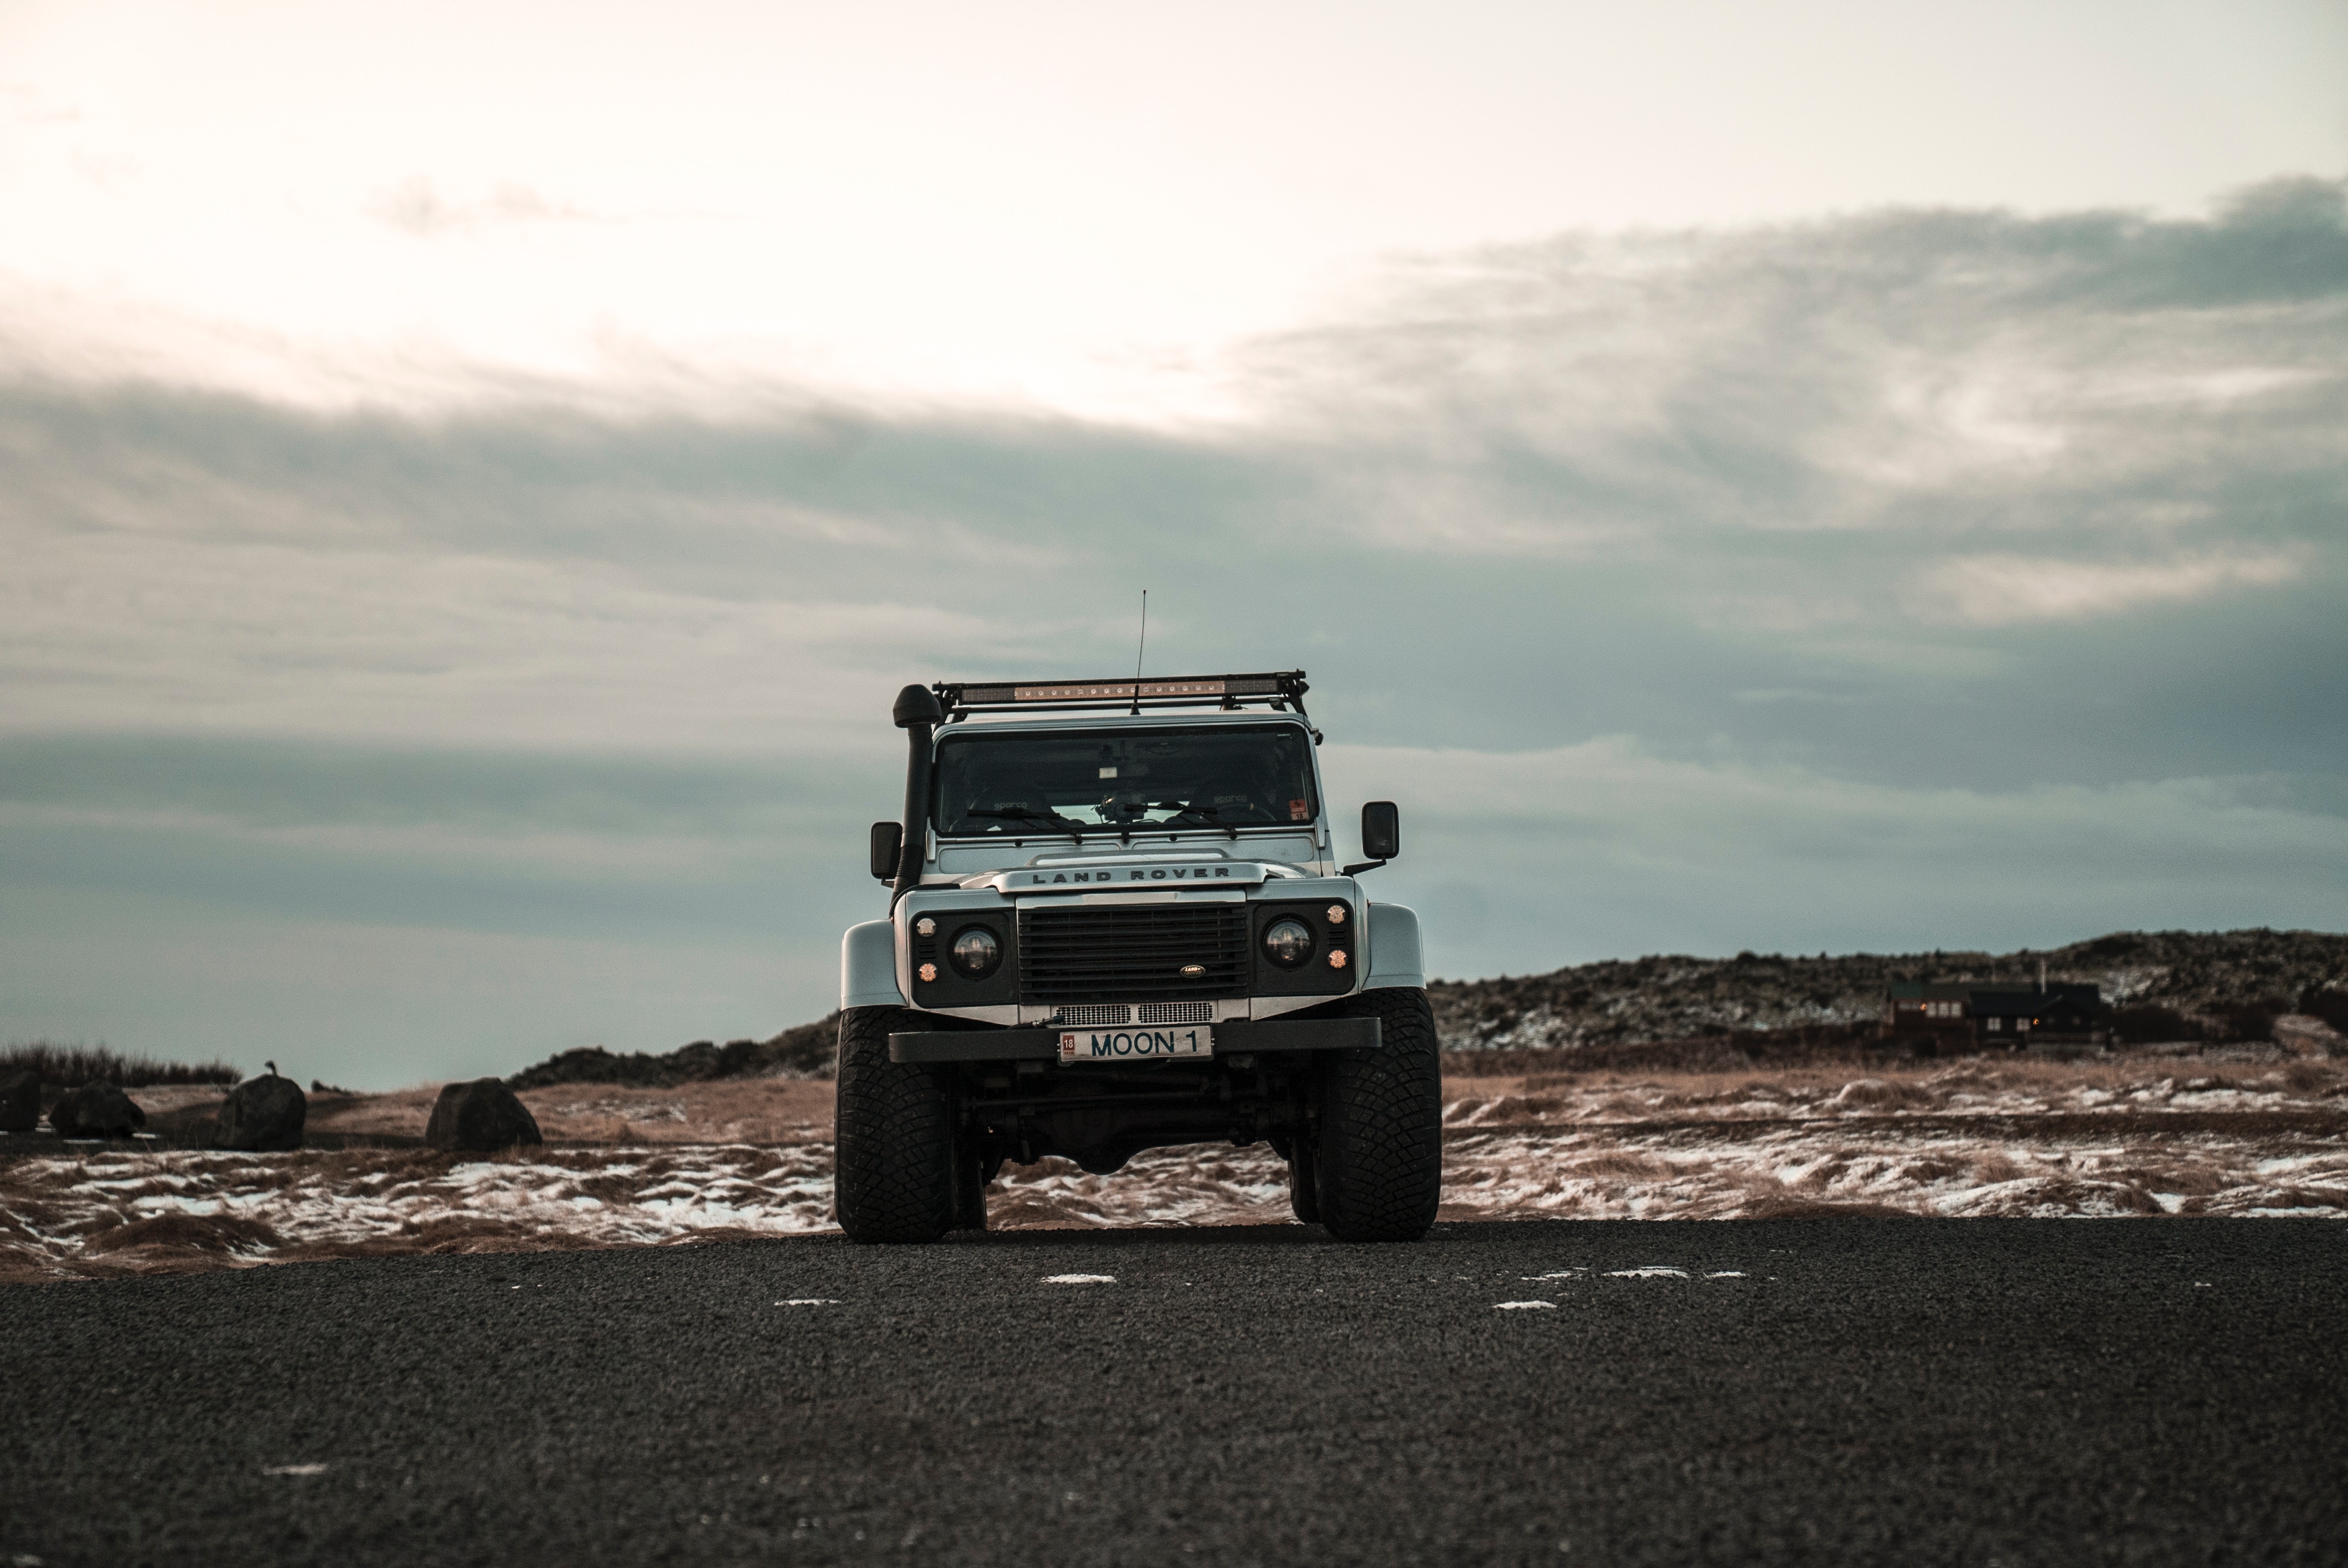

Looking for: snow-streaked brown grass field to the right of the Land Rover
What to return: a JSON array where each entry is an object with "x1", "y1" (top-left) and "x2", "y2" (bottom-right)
[{"x1": 1441, "y1": 1061, "x2": 2348, "y2": 1221}]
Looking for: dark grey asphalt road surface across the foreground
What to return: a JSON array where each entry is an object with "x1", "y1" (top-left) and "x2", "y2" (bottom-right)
[{"x1": 0, "y1": 1218, "x2": 2348, "y2": 1568}]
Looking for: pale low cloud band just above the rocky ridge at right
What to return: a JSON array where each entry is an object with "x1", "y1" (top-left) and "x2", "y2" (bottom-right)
[{"x1": 1324, "y1": 737, "x2": 2348, "y2": 974}]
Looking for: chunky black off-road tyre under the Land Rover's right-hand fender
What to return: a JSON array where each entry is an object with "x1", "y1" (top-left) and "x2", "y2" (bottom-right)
[{"x1": 1312, "y1": 988, "x2": 1444, "y2": 1242}]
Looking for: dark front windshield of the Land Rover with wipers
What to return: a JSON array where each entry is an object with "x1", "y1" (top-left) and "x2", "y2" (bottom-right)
[{"x1": 932, "y1": 723, "x2": 1320, "y2": 838}]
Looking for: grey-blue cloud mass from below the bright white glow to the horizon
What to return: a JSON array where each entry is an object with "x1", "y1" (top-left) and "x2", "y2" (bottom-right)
[{"x1": 0, "y1": 180, "x2": 2348, "y2": 1075}]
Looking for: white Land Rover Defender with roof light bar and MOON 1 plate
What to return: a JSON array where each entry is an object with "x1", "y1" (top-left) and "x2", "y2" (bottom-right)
[{"x1": 836, "y1": 669, "x2": 1441, "y2": 1242}]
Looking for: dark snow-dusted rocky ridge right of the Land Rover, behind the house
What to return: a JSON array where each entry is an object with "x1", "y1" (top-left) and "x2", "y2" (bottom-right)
[{"x1": 1428, "y1": 930, "x2": 2348, "y2": 1051}]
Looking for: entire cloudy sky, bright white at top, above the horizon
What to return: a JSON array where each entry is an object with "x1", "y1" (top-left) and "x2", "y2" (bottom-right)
[{"x1": 0, "y1": 0, "x2": 2348, "y2": 1087}]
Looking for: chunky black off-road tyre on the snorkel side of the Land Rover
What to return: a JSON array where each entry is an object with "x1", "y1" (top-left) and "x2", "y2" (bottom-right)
[{"x1": 831, "y1": 1007, "x2": 958, "y2": 1242}]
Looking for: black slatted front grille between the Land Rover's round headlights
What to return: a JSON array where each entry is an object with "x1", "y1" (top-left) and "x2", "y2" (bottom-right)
[{"x1": 1019, "y1": 904, "x2": 1247, "y2": 1002}]
